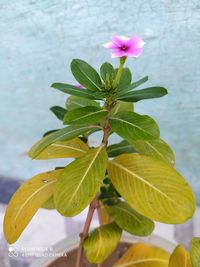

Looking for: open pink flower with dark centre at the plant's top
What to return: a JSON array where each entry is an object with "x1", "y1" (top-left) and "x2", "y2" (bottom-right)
[{"x1": 104, "y1": 35, "x2": 144, "y2": 58}]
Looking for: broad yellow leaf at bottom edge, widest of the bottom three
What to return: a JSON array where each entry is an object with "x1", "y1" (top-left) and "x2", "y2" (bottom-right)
[{"x1": 114, "y1": 243, "x2": 169, "y2": 267}]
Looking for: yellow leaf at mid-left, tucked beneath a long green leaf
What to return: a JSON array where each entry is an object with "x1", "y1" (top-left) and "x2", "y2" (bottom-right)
[{"x1": 29, "y1": 138, "x2": 89, "y2": 160}]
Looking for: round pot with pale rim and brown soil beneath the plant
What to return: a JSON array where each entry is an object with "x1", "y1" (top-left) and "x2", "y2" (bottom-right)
[{"x1": 30, "y1": 234, "x2": 176, "y2": 267}]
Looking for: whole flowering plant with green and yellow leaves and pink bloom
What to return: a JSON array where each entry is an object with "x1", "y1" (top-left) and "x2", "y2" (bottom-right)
[{"x1": 4, "y1": 36, "x2": 200, "y2": 267}]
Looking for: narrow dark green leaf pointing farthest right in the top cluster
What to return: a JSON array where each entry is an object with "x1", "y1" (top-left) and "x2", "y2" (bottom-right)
[{"x1": 118, "y1": 87, "x2": 167, "y2": 103}]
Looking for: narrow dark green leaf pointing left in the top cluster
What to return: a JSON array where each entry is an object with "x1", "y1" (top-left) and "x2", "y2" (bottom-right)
[{"x1": 51, "y1": 83, "x2": 105, "y2": 99}]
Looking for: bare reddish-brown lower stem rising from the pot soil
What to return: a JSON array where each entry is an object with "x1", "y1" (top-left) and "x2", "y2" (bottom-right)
[{"x1": 76, "y1": 193, "x2": 99, "y2": 267}]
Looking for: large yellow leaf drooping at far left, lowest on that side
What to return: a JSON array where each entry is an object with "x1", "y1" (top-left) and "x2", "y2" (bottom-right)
[{"x1": 4, "y1": 170, "x2": 63, "y2": 244}]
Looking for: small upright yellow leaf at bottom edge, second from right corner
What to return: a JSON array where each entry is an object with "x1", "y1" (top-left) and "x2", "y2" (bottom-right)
[{"x1": 168, "y1": 245, "x2": 192, "y2": 267}]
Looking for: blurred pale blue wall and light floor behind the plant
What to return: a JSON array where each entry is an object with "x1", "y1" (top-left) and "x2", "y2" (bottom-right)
[{"x1": 0, "y1": 0, "x2": 200, "y2": 267}]
